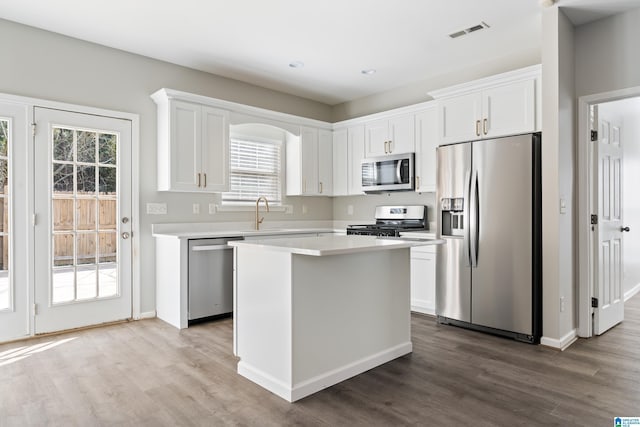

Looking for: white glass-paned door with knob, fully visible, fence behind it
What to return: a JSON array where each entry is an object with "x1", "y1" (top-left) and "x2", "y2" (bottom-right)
[{"x1": 34, "y1": 107, "x2": 132, "y2": 333}]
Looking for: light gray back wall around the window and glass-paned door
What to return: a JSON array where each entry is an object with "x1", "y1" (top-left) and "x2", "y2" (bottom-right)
[{"x1": 0, "y1": 20, "x2": 333, "y2": 312}]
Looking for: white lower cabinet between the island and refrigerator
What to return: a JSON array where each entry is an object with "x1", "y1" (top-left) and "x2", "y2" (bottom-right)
[{"x1": 411, "y1": 246, "x2": 436, "y2": 315}]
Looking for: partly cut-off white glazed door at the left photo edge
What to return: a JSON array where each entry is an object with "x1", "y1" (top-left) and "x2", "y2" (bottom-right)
[{"x1": 0, "y1": 102, "x2": 30, "y2": 342}]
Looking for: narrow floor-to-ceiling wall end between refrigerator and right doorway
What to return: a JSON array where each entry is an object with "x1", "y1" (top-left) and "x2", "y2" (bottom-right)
[{"x1": 542, "y1": 7, "x2": 576, "y2": 346}]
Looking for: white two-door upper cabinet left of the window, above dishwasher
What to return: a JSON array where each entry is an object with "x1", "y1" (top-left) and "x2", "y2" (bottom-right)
[{"x1": 152, "y1": 91, "x2": 229, "y2": 193}]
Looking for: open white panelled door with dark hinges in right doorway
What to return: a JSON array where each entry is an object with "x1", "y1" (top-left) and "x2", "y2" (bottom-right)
[{"x1": 593, "y1": 106, "x2": 624, "y2": 335}]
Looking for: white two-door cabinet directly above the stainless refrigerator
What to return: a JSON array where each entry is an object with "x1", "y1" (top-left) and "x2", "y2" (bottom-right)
[{"x1": 431, "y1": 65, "x2": 541, "y2": 144}]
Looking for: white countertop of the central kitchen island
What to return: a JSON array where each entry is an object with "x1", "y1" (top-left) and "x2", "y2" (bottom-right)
[{"x1": 228, "y1": 235, "x2": 444, "y2": 256}]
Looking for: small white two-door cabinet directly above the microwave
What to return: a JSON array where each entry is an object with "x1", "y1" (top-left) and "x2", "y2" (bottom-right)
[{"x1": 365, "y1": 114, "x2": 415, "y2": 157}]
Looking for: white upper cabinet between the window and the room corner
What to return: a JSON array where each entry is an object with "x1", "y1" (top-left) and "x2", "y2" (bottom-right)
[{"x1": 286, "y1": 127, "x2": 333, "y2": 196}]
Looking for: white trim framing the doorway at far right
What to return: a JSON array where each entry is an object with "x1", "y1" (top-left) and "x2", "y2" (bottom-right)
[{"x1": 576, "y1": 86, "x2": 640, "y2": 338}]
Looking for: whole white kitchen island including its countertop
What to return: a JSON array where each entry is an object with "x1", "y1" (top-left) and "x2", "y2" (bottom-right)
[{"x1": 229, "y1": 236, "x2": 442, "y2": 402}]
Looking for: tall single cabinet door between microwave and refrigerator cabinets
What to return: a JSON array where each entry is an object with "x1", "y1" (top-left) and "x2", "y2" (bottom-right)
[{"x1": 415, "y1": 105, "x2": 438, "y2": 192}]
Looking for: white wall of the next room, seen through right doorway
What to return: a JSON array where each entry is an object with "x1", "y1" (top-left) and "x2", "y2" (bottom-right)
[{"x1": 598, "y1": 98, "x2": 640, "y2": 292}]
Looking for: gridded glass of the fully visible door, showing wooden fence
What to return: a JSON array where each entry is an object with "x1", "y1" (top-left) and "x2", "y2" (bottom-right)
[{"x1": 51, "y1": 127, "x2": 119, "y2": 303}]
